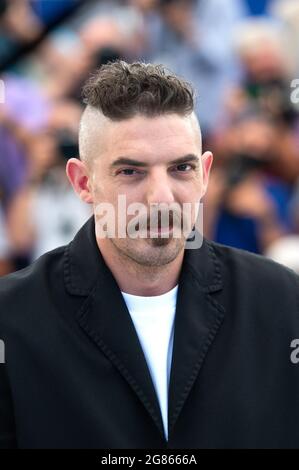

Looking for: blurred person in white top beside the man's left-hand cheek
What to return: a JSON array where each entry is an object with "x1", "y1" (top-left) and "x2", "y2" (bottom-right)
[{"x1": 7, "y1": 129, "x2": 90, "y2": 262}]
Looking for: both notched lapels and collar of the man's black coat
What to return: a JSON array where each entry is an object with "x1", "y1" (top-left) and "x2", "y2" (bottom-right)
[{"x1": 64, "y1": 216, "x2": 225, "y2": 439}]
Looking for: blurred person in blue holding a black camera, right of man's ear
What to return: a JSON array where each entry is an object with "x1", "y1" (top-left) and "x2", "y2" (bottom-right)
[{"x1": 205, "y1": 110, "x2": 292, "y2": 253}]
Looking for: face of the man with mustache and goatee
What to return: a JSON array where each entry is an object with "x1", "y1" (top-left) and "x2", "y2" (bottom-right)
[{"x1": 85, "y1": 114, "x2": 212, "y2": 266}]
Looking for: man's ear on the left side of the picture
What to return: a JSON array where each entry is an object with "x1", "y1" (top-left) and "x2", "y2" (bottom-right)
[{"x1": 66, "y1": 158, "x2": 93, "y2": 204}]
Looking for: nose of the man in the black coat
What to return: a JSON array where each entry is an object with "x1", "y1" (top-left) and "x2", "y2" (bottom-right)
[{"x1": 146, "y1": 170, "x2": 175, "y2": 204}]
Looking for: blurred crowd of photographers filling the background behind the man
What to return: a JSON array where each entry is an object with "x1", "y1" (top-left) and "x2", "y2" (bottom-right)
[{"x1": 0, "y1": 0, "x2": 299, "y2": 275}]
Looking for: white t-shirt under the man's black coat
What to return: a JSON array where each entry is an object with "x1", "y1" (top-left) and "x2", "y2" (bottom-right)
[{"x1": 122, "y1": 286, "x2": 178, "y2": 439}]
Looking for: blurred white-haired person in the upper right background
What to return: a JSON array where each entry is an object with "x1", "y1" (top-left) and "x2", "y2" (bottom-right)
[{"x1": 225, "y1": 19, "x2": 298, "y2": 126}]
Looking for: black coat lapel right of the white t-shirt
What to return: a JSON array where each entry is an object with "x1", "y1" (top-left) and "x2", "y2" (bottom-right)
[{"x1": 168, "y1": 239, "x2": 225, "y2": 437}]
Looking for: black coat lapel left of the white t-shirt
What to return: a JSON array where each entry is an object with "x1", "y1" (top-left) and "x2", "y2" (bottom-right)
[{"x1": 65, "y1": 217, "x2": 164, "y2": 438}]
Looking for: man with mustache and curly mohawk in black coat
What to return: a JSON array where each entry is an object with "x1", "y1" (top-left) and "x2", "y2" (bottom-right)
[{"x1": 0, "y1": 61, "x2": 299, "y2": 449}]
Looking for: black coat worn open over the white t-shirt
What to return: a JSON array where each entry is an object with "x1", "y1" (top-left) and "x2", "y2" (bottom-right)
[{"x1": 0, "y1": 217, "x2": 299, "y2": 449}]
